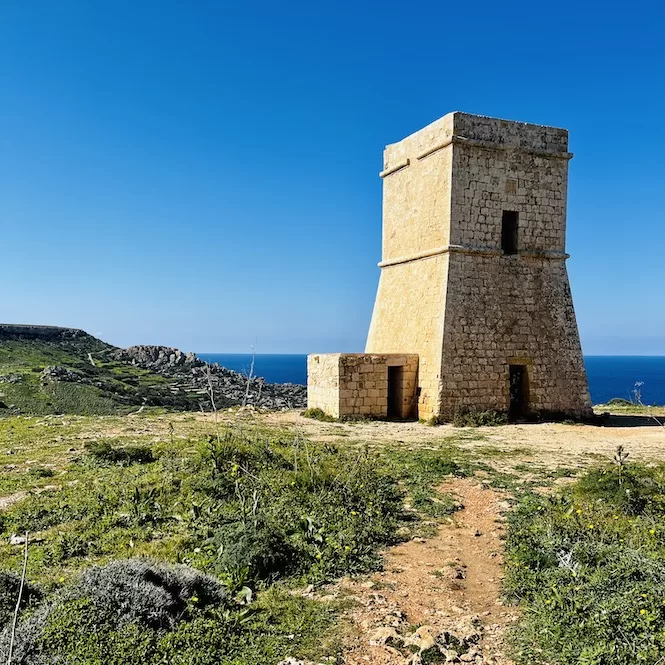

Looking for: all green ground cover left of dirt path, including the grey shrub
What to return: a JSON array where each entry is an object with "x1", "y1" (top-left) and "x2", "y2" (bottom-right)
[{"x1": 0, "y1": 416, "x2": 422, "y2": 665}]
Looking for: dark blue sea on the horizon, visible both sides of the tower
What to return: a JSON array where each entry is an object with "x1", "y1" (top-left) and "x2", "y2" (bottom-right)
[{"x1": 197, "y1": 353, "x2": 665, "y2": 405}]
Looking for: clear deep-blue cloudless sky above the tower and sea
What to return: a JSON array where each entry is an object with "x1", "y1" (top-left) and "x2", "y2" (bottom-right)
[{"x1": 0, "y1": 0, "x2": 665, "y2": 354}]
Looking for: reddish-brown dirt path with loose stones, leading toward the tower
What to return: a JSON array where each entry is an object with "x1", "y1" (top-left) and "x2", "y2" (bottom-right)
[{"x1": 334, "y1": 478, "x2": 516, "y2": 665}]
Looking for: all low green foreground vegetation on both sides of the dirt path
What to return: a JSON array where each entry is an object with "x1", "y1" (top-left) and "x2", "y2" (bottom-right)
[{"x1": 7, "y1": 412, "x2": 665, "y2": 665}]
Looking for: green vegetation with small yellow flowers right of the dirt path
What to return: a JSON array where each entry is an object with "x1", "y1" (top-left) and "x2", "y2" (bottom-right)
[{"x1": 505, "y1": 449, "x2": 665, "y2": 665}]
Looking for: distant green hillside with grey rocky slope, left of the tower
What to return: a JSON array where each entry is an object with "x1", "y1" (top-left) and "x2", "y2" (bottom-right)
[{"x1": 0, "y1": 324, "x2": 306, "y2": 415}]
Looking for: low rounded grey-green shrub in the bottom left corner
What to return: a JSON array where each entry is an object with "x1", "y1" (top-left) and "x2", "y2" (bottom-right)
[{"x1": 0, "y1": 559, "x2": 228, "y2": 665}]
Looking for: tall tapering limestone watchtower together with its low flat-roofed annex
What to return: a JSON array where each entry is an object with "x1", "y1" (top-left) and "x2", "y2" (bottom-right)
[{"x1": 307, "y1": 112, "x2": 591, "y2": 419}]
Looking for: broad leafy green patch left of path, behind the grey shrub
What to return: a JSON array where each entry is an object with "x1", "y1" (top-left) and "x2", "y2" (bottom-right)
[{"x1": 0, "y1": 431, "x2": 402, "y2": 587}]
